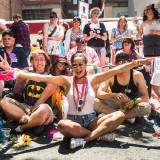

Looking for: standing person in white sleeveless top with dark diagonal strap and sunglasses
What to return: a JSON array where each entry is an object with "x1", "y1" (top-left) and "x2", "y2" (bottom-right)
[{"x1": 42, "y1": 11, "x2": 64, "y2": 63}]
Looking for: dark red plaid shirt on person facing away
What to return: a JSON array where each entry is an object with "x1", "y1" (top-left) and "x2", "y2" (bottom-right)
[{"x1": 11, "y1": 20, "x2": 31, "y2": 49}]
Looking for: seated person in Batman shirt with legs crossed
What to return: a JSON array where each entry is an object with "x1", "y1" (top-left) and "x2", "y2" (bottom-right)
[{"x1": 1, "y1": 50, "x2": 56, "y2": 135}]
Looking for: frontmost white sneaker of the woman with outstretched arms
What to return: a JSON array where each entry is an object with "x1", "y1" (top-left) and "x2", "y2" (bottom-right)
[{"x1": 70, "y1": 138, "x2": 86, "y2": 149}]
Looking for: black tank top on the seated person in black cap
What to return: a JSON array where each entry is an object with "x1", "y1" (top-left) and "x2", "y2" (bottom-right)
[{"x1": 110, "y1": 70, "x2": 138, "y2": 99}]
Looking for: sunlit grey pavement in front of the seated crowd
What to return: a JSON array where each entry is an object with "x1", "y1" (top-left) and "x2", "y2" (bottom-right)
[{"x1": 0, "y1": 119, "x2": 160, "y2": 160}]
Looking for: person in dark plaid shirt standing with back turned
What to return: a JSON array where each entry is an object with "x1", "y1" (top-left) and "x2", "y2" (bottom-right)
[{"x1": 10, "y1": 14, "x2": 31, "y2": 58}]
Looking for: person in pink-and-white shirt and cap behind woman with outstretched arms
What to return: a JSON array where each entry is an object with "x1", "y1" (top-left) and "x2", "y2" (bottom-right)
[{"x1": 67, "y1": 36, "x2": 100, "y2": 74}]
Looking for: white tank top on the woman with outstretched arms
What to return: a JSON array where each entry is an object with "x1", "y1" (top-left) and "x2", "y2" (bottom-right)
[{"x1": 67, "y1": 77, "x2": 95, "y2": 115}]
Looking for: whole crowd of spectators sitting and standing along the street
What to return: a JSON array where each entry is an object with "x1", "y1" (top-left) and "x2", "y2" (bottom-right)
[{"x1": 0, "y1": 4, "x2": 160, "y2": 149}]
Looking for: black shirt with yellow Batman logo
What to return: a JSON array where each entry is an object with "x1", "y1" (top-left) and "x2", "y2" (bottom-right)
[{"x1": 24, "y1": 80, "x2": 51, "y2": 106}]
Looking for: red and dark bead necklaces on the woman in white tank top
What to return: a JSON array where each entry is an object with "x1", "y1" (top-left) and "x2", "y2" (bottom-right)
[{"x1": 73, "y1": 77, "x2": 88, "y2": 113}]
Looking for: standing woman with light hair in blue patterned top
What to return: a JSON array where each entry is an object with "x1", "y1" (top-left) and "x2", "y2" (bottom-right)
[{"x1": 111, "y1": 16, "x2": 131, "y2": 64}]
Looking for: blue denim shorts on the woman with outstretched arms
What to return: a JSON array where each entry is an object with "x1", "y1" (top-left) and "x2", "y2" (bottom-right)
[{"x1": 67, "y1": 112, "x2": 97, "y2": 128}]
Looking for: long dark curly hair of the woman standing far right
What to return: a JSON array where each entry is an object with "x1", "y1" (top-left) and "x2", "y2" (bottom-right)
[{"x1": 143, "y1": 4, "x2": 159, "y2": 22}]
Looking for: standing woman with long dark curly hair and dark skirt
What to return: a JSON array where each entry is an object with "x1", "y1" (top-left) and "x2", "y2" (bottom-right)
[{"x1": 136, "y1": 4, "x2": 160, "y2": 57}]
